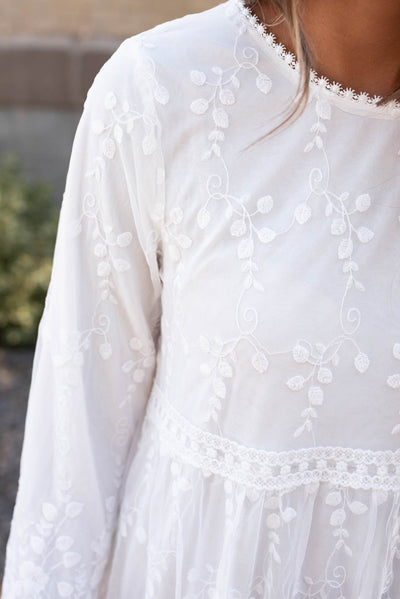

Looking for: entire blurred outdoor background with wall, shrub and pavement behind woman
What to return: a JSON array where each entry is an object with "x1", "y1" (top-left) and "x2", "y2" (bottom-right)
[{"x1": 0, "y1": 0, "x2": 218, "y2": 592}]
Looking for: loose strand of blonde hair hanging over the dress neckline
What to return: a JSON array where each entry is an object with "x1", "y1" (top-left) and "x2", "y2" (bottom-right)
[{"x1": 244, "y1": 0, "x2": 400, "y2": 139}]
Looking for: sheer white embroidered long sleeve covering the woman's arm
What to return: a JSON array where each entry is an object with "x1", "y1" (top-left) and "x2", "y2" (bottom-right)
[{"x1": 2, "y1": 36, "x2": 167, "y2": 599}]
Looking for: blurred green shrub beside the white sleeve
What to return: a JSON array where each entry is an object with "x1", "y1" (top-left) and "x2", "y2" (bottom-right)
[{"x1": 0, "y1": 154, "x2": 59, "y2": 347}]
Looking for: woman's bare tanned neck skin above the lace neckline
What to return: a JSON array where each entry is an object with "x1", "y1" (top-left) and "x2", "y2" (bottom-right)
[{"x1": 247, "y1": 0, "x2": 400, "y2": 96}]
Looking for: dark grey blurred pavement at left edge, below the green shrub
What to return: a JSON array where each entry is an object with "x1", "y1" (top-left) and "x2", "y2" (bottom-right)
[{"x1": 0, "y1": 347, "x2": 33, "y2": 592}]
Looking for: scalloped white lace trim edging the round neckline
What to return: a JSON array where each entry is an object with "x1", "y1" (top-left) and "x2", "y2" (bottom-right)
[{"x1": 233, "y1": 0, "x2": 400, "y2": 116}]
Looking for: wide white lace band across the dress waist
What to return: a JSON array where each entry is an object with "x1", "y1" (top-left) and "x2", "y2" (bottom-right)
[{"x1": 146, "y1": 383, "x2": 400, "y2": 490}]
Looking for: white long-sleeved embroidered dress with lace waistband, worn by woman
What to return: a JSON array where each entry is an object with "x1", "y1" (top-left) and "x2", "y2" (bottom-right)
[{"x1": 2, "y1": 0, "x2": 400, "y2": 599}]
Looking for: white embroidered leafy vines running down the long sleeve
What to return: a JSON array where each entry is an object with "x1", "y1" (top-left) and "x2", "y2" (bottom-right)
[{"x1": 5, "y1": 37, "x2": 168, "y2": 599}]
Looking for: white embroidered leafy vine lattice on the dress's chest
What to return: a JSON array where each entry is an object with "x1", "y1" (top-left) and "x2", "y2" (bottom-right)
[{"x1": 186, "y1": 9, "x2": 374, "y2": 444}]
